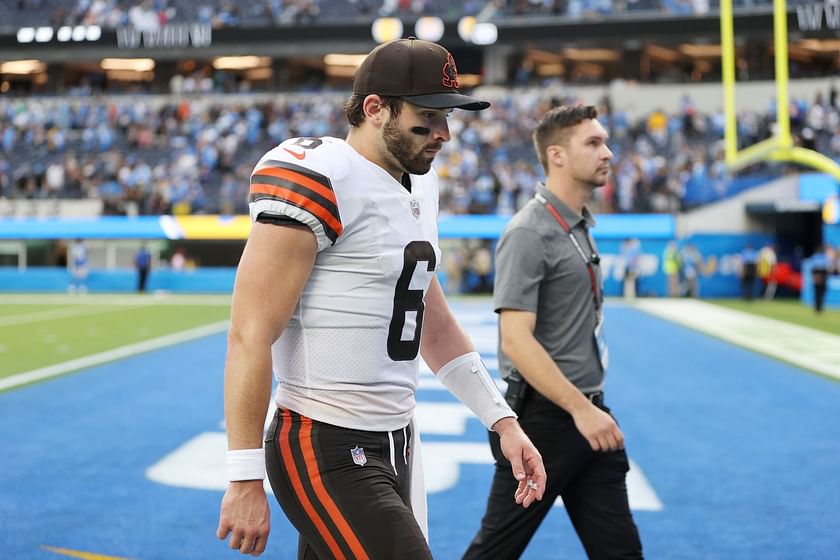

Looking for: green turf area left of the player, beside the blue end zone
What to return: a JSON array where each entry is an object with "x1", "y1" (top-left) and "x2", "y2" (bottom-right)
[{"x1": 0, "y1": 294, "x2": 230, "y2": 378}]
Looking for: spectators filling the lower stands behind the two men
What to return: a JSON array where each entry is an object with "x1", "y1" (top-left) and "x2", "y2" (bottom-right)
[{"x1": 0, "y1": 85, "x2": 840, "y2": 214}]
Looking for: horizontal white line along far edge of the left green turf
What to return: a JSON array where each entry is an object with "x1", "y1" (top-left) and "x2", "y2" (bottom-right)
[{"x1": 0, "y1": 292, "x2": 231, "y2": 306}]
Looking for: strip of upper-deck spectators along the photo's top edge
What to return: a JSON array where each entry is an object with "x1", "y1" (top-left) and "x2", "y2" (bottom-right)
[{"x1": 0, "y1": 0, "x2": 805, "y2": 29}]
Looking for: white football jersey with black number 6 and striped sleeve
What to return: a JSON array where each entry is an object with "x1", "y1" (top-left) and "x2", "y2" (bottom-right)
[{"x1": 250, "y1": 137, "x2": 440, "y2": 431}]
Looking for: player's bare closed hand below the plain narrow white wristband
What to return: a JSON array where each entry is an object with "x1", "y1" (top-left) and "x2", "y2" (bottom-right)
[{"x1": 216, "y1": 480, "x2": 270, "y2": 556}]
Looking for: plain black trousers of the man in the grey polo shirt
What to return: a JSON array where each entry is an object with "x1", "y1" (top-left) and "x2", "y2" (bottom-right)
[{"x1": 464, "y1": 392, "x2": 642, "y2": 560}]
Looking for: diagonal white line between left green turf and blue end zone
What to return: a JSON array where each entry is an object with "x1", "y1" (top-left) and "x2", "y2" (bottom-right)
[{"x1": 0, "y1": 321, "x2": 230, "y2": 391}]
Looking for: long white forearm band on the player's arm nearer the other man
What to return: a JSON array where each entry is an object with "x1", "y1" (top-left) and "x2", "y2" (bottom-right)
[{"x1": 437, "y1": 352, "x2": 516, "y2": 430}]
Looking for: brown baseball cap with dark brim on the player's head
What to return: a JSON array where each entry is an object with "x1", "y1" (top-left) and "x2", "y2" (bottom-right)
[{"x1": 353, "y1": 37, "x2": 490, "y2": 111}]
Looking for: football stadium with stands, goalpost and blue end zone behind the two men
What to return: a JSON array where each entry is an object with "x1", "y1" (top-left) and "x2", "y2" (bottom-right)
[{"x1": 0, "y1": 0, "x2": 840, "y2": 560}]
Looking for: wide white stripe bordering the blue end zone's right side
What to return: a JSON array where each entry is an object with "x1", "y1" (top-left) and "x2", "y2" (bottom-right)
[{"x1": 635, "y1": 299, "x2": 840, "y2": 379}]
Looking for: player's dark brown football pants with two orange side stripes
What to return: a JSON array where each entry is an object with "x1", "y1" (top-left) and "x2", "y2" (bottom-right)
[{"x1": 265, "y1": 410, "x2": 432, "y2": 560}]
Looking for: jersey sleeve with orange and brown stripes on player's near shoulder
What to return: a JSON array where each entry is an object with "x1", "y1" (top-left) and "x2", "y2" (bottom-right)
[{"x1": 249, "y1": 144, "x2": 344, "y2": 251}]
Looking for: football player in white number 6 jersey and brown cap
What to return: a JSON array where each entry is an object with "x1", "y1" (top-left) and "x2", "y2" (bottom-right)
[{"x1": 217, "y1": 38, "x2": 546, "y2": 559}]
